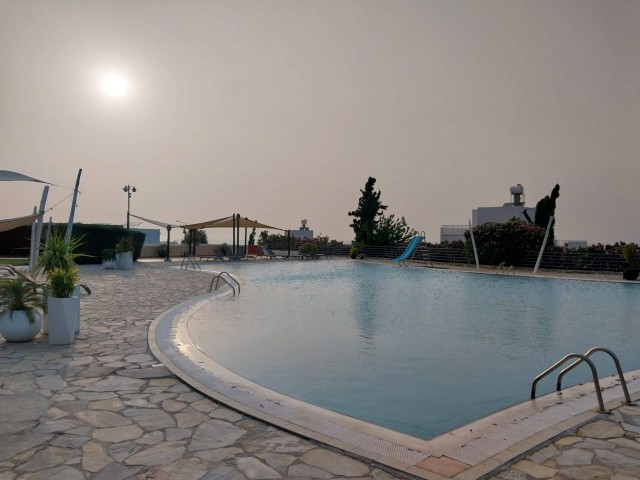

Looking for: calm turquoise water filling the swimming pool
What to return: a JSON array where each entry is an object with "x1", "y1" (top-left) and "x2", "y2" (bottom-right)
[{"x1": 188, "y1": 260, "x2": 640, "y2": 438}]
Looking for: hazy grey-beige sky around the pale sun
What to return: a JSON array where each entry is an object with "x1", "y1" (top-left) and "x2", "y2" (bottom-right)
[{"x1": 0, "y1": 0, "x2": 640, "y2": 243}]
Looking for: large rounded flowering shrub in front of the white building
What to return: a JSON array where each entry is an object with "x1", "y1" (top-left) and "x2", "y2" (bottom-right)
[{"x1": 464, "y1": 218, "x2": 545, "y2": 266}]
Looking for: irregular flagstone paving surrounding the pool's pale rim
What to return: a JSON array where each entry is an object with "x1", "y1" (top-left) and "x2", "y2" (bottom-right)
[{"x1": 0, "y1": 264, "x2": 640, "y2": 480}]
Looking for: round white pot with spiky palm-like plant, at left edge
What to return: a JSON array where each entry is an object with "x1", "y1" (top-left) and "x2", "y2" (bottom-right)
[{"x1": 0, "y1": 275, "x2": 46, "y2": 342}]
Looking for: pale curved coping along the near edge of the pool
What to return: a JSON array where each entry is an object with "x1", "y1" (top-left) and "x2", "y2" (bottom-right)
[{"x1": 148, "y1": 291, "x2": 640, "y2": 480}]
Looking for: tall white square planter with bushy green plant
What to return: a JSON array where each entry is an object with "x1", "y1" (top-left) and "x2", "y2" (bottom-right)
[{"x1": 47, "y1": 267, "x2": 80, "y2": 345}]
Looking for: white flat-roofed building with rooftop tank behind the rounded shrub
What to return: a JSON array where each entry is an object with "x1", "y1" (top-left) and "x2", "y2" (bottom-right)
[{"x1": 440, "y1": 183, "x2": 536, "y2": 242}]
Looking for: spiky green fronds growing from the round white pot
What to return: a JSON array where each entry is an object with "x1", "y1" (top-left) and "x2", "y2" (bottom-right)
[{"x1": 0, "y1": 275, "x2": 46, "y2": 324}]
